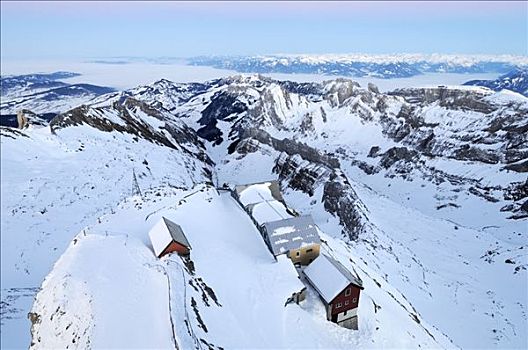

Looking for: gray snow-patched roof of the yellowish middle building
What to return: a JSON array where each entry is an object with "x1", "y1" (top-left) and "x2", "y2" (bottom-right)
[{"x1": 264, "y1": 215, "x2": 321, "y2": 255}]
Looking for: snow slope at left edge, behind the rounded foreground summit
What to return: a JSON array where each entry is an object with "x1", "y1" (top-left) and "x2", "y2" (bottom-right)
[{"x1": 0, "y1": 101, "x2": 209, "y2": 348}]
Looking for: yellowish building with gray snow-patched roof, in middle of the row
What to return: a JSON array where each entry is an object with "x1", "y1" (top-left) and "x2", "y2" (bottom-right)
[{"x1": 263, "y1": 215, "x2": 321, "y2": 265}]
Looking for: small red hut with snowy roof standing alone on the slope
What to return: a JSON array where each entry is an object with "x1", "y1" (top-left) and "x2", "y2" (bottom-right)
[{"x1": 149, "y1": 217, "x2": 191, "y2": 258}]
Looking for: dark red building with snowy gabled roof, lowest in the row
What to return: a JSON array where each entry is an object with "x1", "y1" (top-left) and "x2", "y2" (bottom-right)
[{"x1": 303, "y1": 254, "x2": 363, "y2": 330}]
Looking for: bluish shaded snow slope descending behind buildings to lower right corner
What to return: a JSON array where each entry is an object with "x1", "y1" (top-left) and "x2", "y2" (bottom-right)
[{"x1": 200, "y1": 143, "x2": 528, "y2": 348}]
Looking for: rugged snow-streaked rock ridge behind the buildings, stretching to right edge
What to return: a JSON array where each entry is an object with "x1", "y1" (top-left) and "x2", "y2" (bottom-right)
[{"x1": 106, "y1": 76, "x2": 528, "y2": 226}]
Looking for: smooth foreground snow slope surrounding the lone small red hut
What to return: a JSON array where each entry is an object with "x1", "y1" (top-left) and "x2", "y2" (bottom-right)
[{"x1": 27, "y1": 186, "x2": 451, "y2": 349}]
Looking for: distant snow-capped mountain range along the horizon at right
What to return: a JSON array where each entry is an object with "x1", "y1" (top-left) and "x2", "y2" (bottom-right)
[{"x1": 189, "y1": 54, "x2": 528, "y2": 79}]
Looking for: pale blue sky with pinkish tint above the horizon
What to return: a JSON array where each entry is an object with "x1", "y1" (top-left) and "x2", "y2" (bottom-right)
[{"x1": 1, "y1": 1, "x2": 528, "y2": 58}]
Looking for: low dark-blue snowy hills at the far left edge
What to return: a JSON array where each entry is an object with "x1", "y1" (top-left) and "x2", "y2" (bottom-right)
[{"x1": 0, "y1": 72, "x2": 115, "y2": 114}]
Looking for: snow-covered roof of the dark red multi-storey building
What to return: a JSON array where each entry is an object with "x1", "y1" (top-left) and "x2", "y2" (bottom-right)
[{"x1": 303, "y1": 254, "x2": 363, "y2": 303}]
